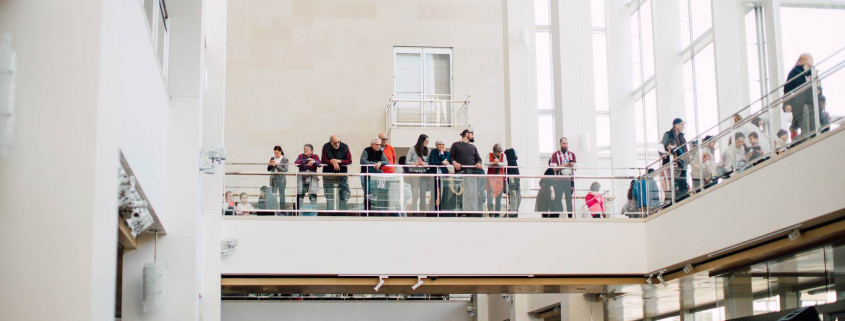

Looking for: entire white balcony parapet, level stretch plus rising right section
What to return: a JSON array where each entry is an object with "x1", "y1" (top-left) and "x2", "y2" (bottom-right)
[{"x1": 221, "y1": 132, "x2": 845, "y2": 275}]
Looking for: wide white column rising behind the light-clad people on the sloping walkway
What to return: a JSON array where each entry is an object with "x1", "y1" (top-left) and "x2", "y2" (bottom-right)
[{"x1": 712, "y1": 0, "x2": 750, "y2": 117}]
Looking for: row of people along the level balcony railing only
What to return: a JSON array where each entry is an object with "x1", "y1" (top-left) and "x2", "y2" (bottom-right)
[{"x1": 219, "y1": 129, "x2": 604, "y2": 217}]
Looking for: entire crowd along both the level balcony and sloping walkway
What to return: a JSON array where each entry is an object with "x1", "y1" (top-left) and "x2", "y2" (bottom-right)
[{"x1": 224, "y1": 54, "x2": 830, "y2": 218}]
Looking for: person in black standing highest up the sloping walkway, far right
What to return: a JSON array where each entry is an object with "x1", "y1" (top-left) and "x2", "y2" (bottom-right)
[{"x1": 783, "y1": 53, "x2": 816, "y2": 138}]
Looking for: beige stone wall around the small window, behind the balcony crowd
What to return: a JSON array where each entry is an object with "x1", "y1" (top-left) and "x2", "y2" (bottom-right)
[{"x1": 225, "y1": 0, "x2": 505, "y2": 162}]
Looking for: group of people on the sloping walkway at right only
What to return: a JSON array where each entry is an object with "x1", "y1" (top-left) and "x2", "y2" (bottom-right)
[{"x1": 626, "y1": 53, "x2": 831, "y2": 211}]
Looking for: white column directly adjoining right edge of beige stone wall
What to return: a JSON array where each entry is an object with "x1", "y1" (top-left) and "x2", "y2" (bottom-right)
[{"x1": 502, "y1": 0, "x2": 540, "y2": 166}]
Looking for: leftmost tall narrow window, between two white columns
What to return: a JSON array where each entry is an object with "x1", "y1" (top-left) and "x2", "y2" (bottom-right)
[{"x1": 534, "y1": 0, "x2": 556, "y2": 153}]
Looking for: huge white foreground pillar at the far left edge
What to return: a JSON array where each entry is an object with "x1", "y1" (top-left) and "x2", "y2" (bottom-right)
[{"x1": 0, "y1": 0, "x2": 119, "y2": 321}]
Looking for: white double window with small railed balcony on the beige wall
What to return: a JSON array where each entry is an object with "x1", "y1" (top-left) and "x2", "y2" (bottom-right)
[{"x1": 393, "y1": 47, "x2": 454, "y2": 124}]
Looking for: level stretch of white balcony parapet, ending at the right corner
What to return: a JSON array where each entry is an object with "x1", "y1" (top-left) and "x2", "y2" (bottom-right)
[{"x1": 221, "y1": 218, "x2": 645, "y2": 275}]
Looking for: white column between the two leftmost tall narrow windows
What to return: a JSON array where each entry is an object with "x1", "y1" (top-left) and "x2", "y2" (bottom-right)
[{"x1": 552, "y1": 0, "x2": 598, "y2": 168}]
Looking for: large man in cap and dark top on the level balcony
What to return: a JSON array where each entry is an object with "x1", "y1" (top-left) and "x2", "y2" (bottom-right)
[{"x1": 449, "y1": 129, "x2": 484, "y2": 216}]
